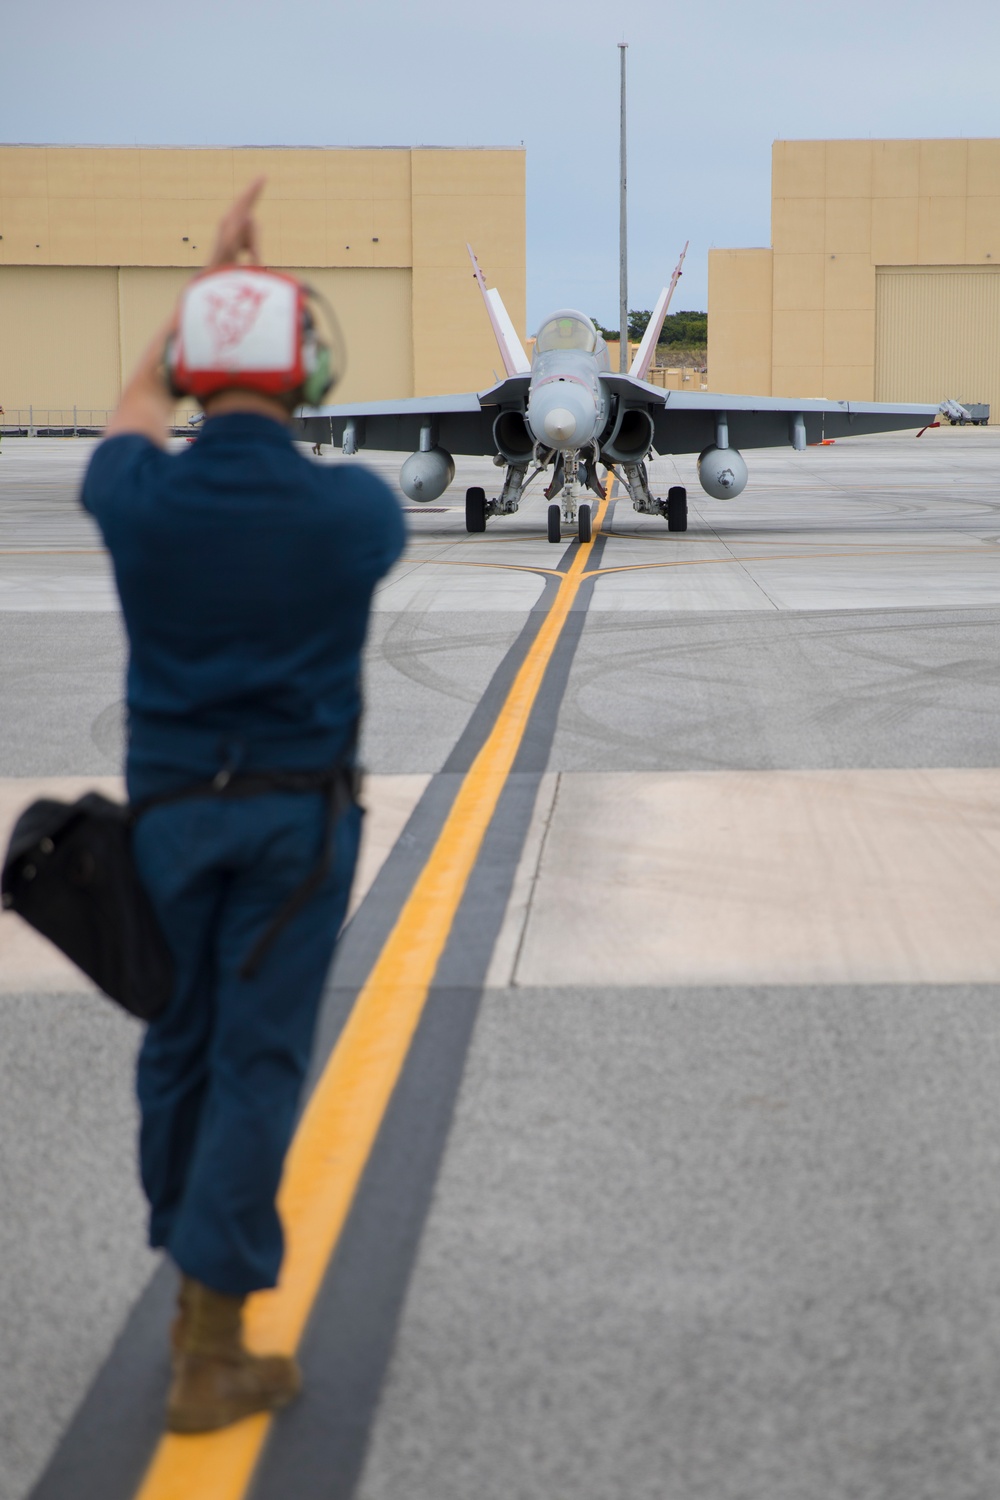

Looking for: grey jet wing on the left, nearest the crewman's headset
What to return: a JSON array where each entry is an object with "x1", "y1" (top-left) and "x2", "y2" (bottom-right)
[{"x1": 297, "y1": 375, "x2": 531, "y2": 456}]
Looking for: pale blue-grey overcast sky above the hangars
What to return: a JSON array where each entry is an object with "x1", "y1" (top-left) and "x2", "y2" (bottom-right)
[{"x1": 0, "y1": 0, "x2": 1000, "y2": 329}]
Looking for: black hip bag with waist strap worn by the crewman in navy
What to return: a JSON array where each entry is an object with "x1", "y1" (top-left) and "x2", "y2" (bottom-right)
[{"x1": 0, "y1": 765, "x2": 360, "y2": 1022}]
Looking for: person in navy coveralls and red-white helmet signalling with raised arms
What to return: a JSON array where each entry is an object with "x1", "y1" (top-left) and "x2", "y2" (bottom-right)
[{"x1": 82, "y1": 183, "x2": 403, "y2": 1431}]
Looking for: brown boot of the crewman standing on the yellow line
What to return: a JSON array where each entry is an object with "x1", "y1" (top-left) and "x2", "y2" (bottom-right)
[{"x1": 166, "y1": 1277, "x2": 301, "y2": 1433}]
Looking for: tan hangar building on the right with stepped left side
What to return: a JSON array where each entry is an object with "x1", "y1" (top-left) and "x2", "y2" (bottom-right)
[{"x1": 709, "y1": 140, "x2": 1000, "y2": 422}]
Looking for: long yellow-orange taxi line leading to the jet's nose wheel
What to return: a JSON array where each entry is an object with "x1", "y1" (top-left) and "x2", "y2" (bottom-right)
[{"x1": 135, "y1": 483, "x2": 610, "y2": 1500}]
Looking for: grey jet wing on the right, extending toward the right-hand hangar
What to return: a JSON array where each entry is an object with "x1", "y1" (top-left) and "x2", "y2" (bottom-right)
[{"x1": 601, "y1": 375, "x2": 940, "y2": 453}]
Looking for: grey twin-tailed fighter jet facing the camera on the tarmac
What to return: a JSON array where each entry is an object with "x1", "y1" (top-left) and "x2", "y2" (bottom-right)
[{"x1": 301, "y1": 246, "x2": 939, "y2": 542}]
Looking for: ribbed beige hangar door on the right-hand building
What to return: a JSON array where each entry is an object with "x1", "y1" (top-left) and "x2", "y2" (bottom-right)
[{"x1": 876, "y1": 266, "x2": 1000, "y2": 423}]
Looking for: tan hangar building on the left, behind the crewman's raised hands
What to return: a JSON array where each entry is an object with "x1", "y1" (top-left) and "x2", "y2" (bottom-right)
[{"x1": 0, "y1": 146, "x2": 525, "y2": 422}]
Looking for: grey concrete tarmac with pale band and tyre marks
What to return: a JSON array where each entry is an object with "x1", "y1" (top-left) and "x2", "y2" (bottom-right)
[{"x1": 0, "y1": 429, "x2": 1000, "y2": 1500}]
